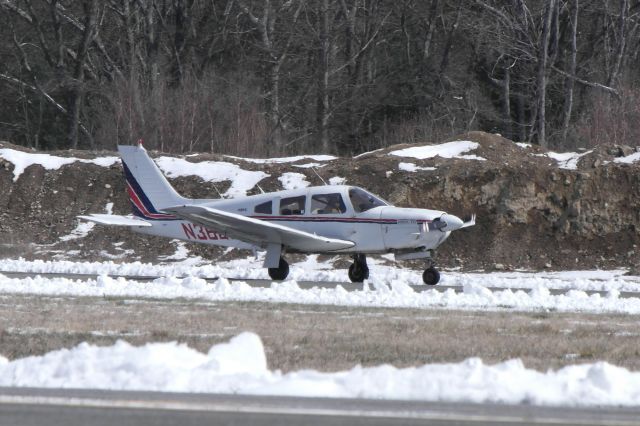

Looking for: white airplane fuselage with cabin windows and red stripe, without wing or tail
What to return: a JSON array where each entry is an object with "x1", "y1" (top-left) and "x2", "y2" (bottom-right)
[{"x1": 135, "y1": 185, "x2": 457, "y2": 253}]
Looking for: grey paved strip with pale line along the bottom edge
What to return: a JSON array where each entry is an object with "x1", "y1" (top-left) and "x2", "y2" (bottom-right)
[{"x1": 0, "y1": 388, "x2": 640, "y2": 426}]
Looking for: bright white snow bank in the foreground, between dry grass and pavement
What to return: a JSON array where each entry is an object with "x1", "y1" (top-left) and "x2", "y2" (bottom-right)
[{"x1": 0, "y1": 332, "x2": 640, "y2": 406}]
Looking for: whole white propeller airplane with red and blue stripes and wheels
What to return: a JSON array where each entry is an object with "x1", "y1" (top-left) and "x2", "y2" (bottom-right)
[{"x1": 79, "y1": 144, "x2": 475, "y2": 285}]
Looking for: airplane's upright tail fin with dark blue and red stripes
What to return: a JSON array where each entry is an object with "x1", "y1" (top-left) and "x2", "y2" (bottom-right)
[{"x1": 118, "y1": 145, "x2": 189, "y2": 220}]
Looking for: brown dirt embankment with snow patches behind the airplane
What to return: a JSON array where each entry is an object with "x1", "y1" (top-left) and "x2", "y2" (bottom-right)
[{"x1": 0, "y1": 132, "x2": 640, "y2": 270}]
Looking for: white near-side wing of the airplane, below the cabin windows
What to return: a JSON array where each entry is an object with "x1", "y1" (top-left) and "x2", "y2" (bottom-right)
[{"x1": 162, "y1": 205, "x2": 355, "y2": 252}]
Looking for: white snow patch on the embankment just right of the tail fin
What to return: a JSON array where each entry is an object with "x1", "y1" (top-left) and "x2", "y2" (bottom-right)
[{"x1": 155, "y1": 157, "x2": 269, "y2": 197}]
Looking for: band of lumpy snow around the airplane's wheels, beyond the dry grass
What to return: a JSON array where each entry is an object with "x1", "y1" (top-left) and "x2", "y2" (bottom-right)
[{"x1": 0, "y1": 256, "x2": 640, "y2": 314}]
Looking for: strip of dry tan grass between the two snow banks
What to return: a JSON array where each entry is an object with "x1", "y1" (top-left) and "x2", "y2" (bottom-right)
[{"x1": 0, "y1": 296, "x2": 640, "y2": 371}]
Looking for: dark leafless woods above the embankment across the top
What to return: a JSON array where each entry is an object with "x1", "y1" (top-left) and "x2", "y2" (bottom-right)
[{"x1": 0, "y1": 0, "x2": 640, "y2": 155}]
